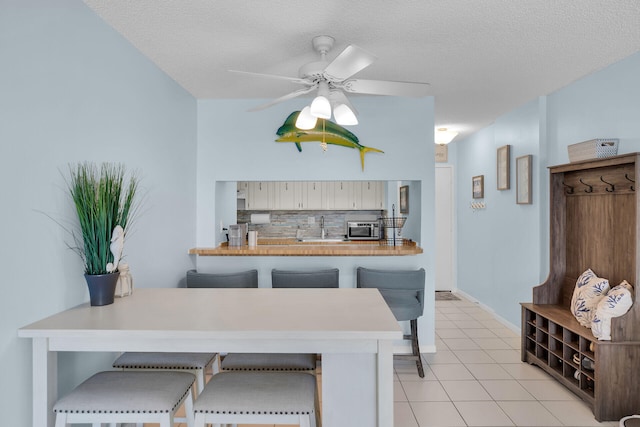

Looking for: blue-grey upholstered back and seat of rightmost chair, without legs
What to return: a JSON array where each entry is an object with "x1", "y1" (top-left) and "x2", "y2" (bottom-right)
[{"x1": 357, "y1": 267, "x2": 425, "y2": 320}]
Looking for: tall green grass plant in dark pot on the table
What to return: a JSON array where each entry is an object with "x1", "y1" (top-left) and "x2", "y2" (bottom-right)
[{"x1": 67, "y1": 162, "x2": 139, "y2": 306}]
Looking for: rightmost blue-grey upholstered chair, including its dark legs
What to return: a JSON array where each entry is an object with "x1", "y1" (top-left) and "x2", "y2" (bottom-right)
[{"x1": 357, "y1": 267, "x2": 425, "y2": 378}]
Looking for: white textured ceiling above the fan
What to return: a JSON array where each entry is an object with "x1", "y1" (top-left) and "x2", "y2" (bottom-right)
[{"x1": 84, "y1": 0, "x2": 640, "y2": 139}]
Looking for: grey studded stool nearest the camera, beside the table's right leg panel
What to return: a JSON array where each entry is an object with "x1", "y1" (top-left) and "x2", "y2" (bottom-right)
[{"x1": 193, "y1": 372, "x2": 316, "y2": 427}]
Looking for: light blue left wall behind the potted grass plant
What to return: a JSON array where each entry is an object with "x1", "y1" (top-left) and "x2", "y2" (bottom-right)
[{"x1": 0, "y1": 0, "x2": 197, "y2": 426}]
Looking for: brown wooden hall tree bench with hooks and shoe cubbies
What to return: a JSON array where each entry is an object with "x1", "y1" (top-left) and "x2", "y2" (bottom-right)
[{"x1": 522, "y1": 153, "x2": 640, "y2": 421}]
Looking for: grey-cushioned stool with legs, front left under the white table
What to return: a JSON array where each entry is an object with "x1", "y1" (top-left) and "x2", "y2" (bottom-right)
[{"x1": 53, "y1": 371, "x2": 195, "y2": 427}]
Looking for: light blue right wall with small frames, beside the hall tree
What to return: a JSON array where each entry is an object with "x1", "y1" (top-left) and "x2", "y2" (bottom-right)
[{"x1": 454, "y1": 54, "x2": 640, "y2": 327}]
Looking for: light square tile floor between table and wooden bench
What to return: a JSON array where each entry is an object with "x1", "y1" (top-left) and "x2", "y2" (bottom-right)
[{"x1": 171, "y1": 298, "x2": 618, "y2": 427}]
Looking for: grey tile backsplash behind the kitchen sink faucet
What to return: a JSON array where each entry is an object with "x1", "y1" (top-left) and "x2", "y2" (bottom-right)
[{"x1": 237, "y1": 210, "x2": 386, "y2": 239}]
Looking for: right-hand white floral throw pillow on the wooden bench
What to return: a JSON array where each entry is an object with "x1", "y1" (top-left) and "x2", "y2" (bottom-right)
[{"x1": 591, "y1": 280, "x2": 633, "y2": 341}]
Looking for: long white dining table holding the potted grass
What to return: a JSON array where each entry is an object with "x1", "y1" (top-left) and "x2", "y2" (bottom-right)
[{"x1": 18, "y1": 288, "x2": 402, "y2": 427}]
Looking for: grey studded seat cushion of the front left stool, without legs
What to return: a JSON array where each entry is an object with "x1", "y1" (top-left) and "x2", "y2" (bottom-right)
[{"x1": 53, "y1": 371, "x2": 195, "y2": 414}]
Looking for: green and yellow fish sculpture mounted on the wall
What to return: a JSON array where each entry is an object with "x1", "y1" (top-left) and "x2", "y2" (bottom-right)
[{"x1": 276, "y1": 111, "x2": 384, "y2": 170}]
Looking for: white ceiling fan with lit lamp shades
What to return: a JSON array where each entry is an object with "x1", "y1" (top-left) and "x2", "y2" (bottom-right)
[{"x1": 229, "y1": 36, "x2": 429, "y2": 129}]
